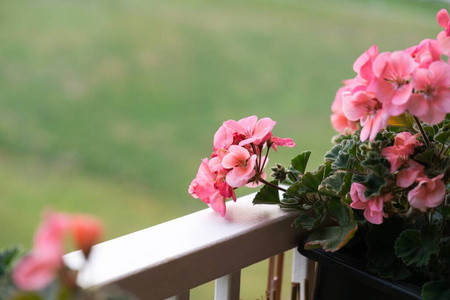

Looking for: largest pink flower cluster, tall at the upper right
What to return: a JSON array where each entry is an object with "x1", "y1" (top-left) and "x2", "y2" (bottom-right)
[{"x1": 331, "y1": 9, "x2": 450, "y2": 141}]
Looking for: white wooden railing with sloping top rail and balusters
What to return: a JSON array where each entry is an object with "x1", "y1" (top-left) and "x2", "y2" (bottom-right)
[{"x1": 64, "y1": 194, "x2": 312, "y2": 300}]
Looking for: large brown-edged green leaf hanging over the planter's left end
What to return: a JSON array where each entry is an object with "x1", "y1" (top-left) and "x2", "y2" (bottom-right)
[{"x1": 305, "y1": 200, "x2": 358, "y2": 252}]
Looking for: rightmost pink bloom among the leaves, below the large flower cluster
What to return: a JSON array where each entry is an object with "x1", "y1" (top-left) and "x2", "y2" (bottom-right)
[{"x1": 408, "y1": 174, "x2": 445, "y2": 210}]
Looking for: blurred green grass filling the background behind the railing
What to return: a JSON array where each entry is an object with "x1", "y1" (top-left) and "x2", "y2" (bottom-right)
[{"x1": 0, "y1": 0, "x2": 445, "y2": 299}]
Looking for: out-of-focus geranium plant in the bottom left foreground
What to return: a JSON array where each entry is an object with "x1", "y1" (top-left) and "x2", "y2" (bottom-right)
[{"x1": 0, "y1": 211, "x2": 134, "y2": 300}]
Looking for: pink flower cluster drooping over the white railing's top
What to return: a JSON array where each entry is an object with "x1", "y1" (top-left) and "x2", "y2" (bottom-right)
[{"x1": 189, "y1": 116, "x2": 295, "y2": 216}]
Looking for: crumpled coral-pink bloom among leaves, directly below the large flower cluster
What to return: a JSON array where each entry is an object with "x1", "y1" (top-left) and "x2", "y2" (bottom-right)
[{"x1": 381, "y1": 131, "x2": 420, "y2": 173}]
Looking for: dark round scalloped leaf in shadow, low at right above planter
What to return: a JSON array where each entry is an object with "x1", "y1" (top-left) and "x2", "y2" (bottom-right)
[{"x1": 395, "y1": 225, "x2": 439, "y2": 267}]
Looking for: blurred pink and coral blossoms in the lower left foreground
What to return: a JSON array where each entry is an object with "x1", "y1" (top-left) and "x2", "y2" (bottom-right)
[{"x1": 13, "y1": 212, "x2": 103, "y2": 291}]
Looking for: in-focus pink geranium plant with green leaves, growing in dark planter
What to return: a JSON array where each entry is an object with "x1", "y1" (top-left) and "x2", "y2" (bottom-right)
[{"x1": 189, "y1": 9, "x2": 450, "y2": 299}]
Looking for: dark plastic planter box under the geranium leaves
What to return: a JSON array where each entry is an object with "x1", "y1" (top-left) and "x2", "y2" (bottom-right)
[{"x1": 298, "y1": 245, "x2": 422, "y2": 300}]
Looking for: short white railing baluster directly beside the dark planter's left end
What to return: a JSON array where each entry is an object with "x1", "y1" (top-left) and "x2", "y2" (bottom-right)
[{"x1": 291, "y1": 249, "x2": 316, "y2": 300}]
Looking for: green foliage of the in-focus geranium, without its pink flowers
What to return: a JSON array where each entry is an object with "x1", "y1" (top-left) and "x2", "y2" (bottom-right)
[{"x1": 254, "y1": 117, "x2": 450, "y2": 299}]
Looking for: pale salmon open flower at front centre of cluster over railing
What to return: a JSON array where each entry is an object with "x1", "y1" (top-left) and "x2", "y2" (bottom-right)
[{"x1": 222, "y1": 145, "x2": 256, "y2": 187}]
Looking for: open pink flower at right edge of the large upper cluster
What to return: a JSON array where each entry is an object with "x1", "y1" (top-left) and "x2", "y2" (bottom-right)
[{"x1": 408, "y1": 61, "x2": 450, "y2": 124}]
